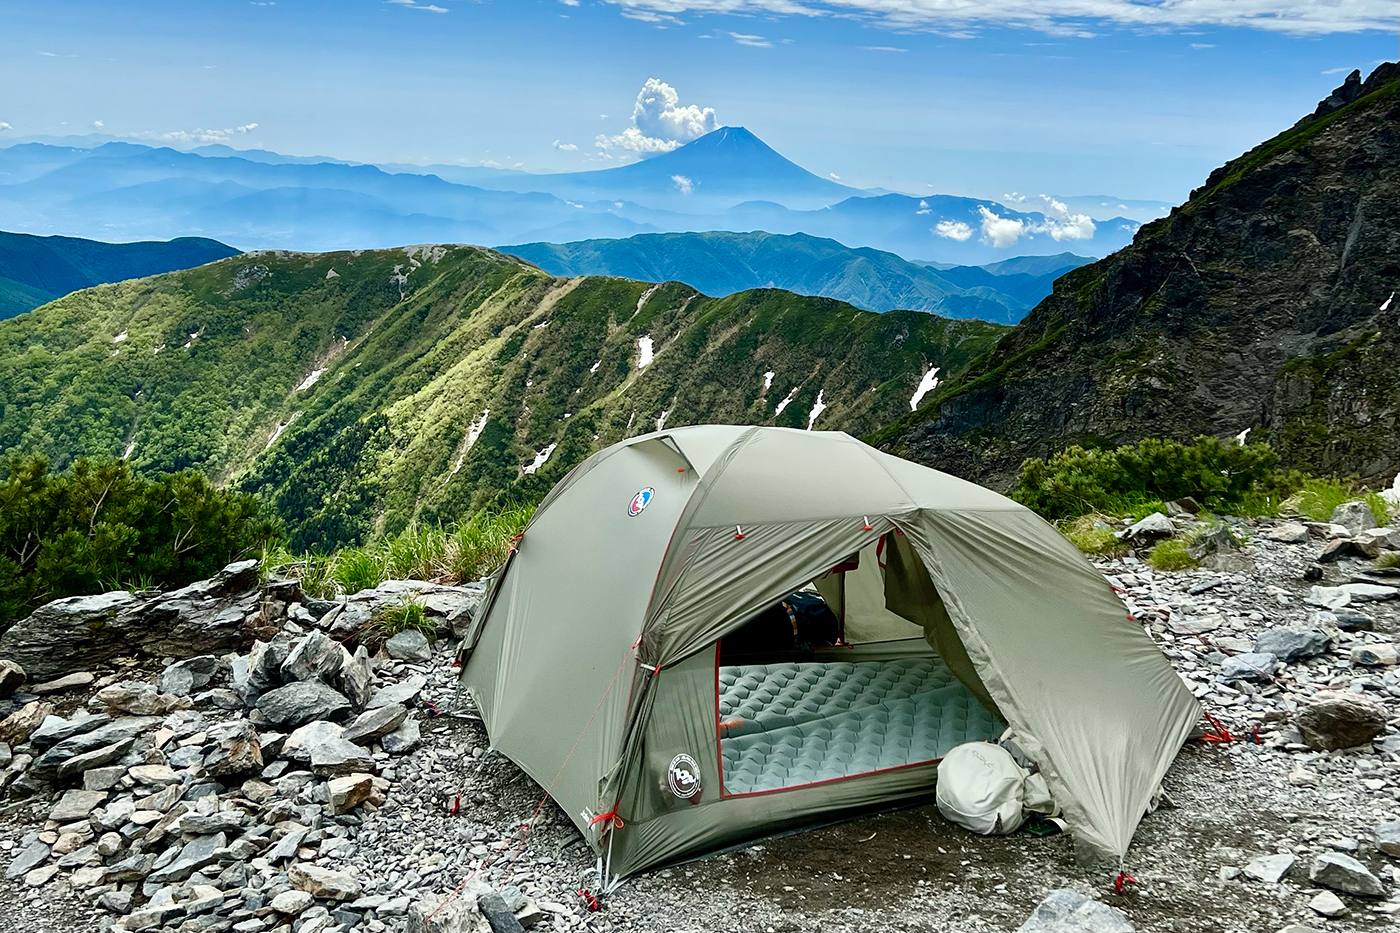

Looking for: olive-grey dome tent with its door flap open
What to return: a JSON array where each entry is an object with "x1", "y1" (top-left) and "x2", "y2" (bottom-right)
[{"x1": 459, "y1": 424, "x2": 1198, "y2": 881}]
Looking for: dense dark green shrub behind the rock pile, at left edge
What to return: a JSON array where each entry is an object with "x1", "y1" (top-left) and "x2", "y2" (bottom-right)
[{"x1": 0, "y1": 455, "x2": 277, "y2": 632}]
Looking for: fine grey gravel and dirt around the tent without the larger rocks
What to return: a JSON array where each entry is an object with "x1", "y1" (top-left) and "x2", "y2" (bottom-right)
[{"x1": 0, "y1": 512, "x2": 1400, "y2": 933}]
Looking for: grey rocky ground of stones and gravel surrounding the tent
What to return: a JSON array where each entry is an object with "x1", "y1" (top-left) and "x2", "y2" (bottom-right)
[{"x1": 0, "y1": 504, "x2": 1400, "y2": 933}]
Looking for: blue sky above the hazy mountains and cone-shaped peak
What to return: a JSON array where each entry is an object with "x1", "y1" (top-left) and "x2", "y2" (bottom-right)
[{"x1": 0, "y1": 0, "x2": 1400, "y2": 202}]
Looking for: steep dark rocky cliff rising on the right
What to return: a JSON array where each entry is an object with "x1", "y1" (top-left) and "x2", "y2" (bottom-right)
[{"x1": 878, "y1": 63, "x2": 1400, "y2": 483}]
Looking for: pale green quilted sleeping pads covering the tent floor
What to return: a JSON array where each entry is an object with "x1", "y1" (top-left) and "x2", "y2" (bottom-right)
[{"x1": 718, "y1": 657, "x2": 1005, "y2": 796}]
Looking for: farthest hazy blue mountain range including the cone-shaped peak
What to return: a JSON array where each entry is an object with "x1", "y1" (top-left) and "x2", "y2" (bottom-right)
[{"x1": 0, "y1": 127, "x2": 1138, "y2": 265}]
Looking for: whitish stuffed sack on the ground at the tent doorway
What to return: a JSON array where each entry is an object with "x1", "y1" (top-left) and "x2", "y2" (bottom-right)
[{"x1": 937, "y1": 742, "x2": 1029, "y2": 836}]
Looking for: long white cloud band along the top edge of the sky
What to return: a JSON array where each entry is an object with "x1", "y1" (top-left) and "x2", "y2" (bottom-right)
[{"x1": 608, "y1": 0, "x2": 1400, "y2": 38}]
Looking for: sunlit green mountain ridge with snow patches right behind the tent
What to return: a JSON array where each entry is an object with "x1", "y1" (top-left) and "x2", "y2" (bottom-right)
[{"x1": 0, "y1": 247, "x2": 1005, "y2": 546}]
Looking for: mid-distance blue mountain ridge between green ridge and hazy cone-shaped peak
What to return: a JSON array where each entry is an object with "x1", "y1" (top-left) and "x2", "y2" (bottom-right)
[{"x1": 501, "y1": 231, "x2": 1092, "y2": 324}]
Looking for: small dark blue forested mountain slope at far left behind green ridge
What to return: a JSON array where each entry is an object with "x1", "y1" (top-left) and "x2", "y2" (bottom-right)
[{"x1": 0, "y1": 231, "x2": 238, "y2": 319}]
